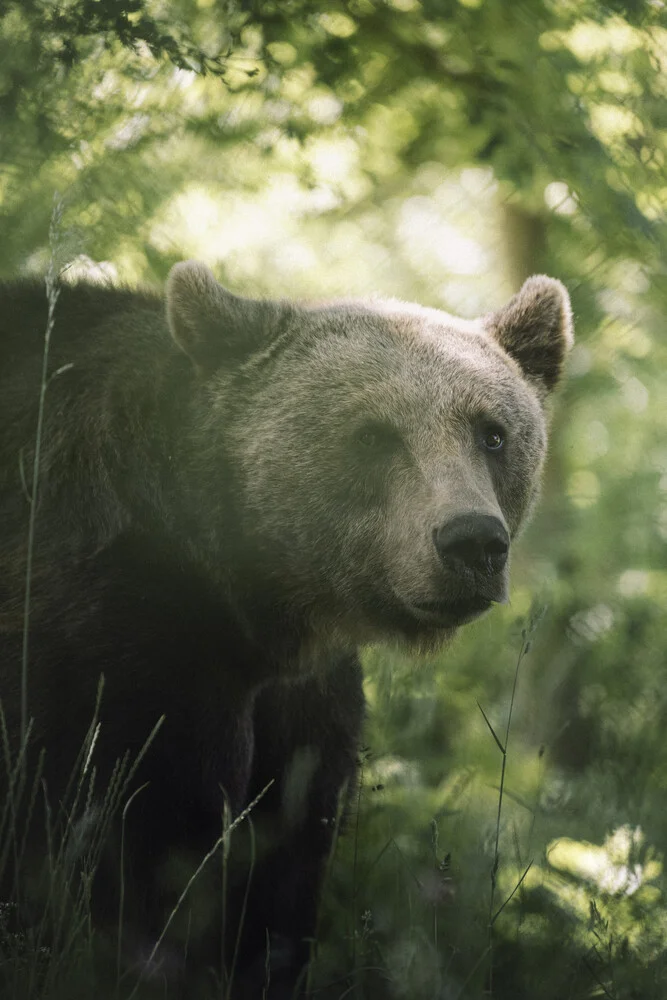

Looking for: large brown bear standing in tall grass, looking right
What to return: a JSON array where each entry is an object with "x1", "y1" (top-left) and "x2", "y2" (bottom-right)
[{"x1": 0, "y1": 262, "x2": 572, "y2": 998}]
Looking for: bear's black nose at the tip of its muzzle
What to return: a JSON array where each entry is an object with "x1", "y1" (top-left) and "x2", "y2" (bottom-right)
[{"x1": 433, "y1": 514, "x2": 510, "y2": 576}]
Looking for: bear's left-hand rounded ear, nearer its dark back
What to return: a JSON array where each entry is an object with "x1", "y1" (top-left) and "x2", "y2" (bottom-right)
[{"x1": 166, "y1": 260, "x2": 282, "y2": 375}]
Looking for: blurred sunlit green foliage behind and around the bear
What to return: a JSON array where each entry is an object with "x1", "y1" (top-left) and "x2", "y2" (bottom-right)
[{"x1": 0, "y1": 0, "x2": 667, "y2": 1000}]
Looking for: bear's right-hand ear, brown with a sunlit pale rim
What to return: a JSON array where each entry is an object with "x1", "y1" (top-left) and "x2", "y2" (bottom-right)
[{"x1": 483, "y1": 274, "x2": 574, "y2": 394}]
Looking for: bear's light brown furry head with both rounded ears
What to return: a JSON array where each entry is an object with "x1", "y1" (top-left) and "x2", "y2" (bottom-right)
[{"x1": 167, "y1": 262, "x2": 573, "y2": 647}]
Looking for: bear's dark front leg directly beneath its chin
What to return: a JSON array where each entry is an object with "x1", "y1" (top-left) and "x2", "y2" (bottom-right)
[{"x1": 232, "y1": 655, "x2": 364, "y2": 1000}]
